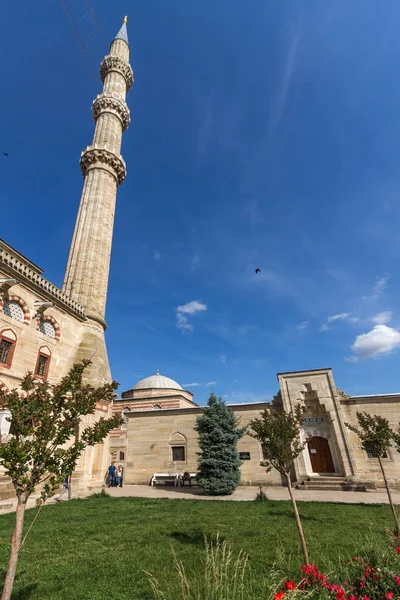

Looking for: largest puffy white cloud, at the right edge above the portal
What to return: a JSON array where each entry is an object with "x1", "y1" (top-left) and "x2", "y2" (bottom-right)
[{"x1": 347, "y1": 325, "x2": 400, "y2": 362}]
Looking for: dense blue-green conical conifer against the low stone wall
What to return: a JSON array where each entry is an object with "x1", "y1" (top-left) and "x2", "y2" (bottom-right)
[{"x1": 195, "y1": 394, "x2": 246, "y2": 496}]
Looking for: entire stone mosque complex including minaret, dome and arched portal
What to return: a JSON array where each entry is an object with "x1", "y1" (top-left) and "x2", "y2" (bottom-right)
[{"x1": 0, "y1": 18, "x2": 400, "y2": 499}]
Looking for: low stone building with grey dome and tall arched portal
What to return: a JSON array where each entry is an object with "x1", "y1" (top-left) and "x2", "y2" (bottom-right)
[{"x1": 110, "y1": 369, "x2": 400, "y2": 490}]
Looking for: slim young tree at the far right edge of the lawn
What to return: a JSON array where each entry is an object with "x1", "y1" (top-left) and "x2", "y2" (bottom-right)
[{"x1": 346, "y1": 412, "x2": 399, "y2": 533}]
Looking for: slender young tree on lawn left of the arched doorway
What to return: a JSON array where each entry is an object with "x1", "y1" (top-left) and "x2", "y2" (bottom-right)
[{"x1": 249, "y1": 404, "x2": 310, "y2": 565}]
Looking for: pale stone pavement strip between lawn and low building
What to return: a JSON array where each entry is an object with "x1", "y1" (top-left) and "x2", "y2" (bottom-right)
[{"x1": 0, "y1": 484, "x2": 400, "y2": 514}]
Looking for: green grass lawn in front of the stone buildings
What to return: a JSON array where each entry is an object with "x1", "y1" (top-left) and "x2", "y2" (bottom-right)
[{"x1": 0, "y1": 497, "x2": 392, "y2": 600}]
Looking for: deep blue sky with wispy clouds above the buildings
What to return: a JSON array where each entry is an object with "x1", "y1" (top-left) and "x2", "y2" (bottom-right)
[{"x1": 0, "y1": 0, "x2": 400, "y2": 402}]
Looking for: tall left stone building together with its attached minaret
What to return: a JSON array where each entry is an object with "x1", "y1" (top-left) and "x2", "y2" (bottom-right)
[{"x1": 0, "y1": 19, "x2": 133, "y2": 497}]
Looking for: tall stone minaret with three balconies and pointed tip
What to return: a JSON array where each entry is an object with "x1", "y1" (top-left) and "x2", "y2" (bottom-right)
[{"x1": 63, "y1": 17, "x2": 133, "y2": 385}]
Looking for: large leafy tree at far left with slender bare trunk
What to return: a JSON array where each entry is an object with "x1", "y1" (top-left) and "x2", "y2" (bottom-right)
[{"x1": 0, "y1": 360, "x2": 120, "y2": 600}]
